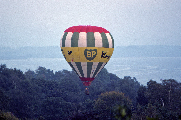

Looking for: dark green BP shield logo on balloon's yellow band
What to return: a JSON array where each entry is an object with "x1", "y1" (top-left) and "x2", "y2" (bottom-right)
[{"x1": 84, "y1": 49, "x2": 97, "y2": 61}]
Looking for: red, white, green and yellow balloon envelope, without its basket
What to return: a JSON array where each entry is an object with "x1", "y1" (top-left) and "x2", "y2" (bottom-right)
[{"x1": 60, "y1": 25, "x2": 114, "y2": 86}]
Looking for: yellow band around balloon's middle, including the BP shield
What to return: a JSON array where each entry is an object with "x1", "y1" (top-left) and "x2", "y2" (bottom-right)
[{"x1": 61, "y1": 47, "x2": 114, "y2": 62}]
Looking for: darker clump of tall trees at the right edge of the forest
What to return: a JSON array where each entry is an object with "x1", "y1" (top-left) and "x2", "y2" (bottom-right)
[{"x1": 134, "y1": 79, "x2": 181, "y2": 120}]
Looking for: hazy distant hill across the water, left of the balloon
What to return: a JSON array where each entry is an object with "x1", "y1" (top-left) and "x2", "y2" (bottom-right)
[{"x1": 0, "y1": 46, "x2": 63, "y2": 59}]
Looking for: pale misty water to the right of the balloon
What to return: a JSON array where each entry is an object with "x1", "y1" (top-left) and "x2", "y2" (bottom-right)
[{"x1": 106, "y1": 57, "x2": 181, "y2": 85}]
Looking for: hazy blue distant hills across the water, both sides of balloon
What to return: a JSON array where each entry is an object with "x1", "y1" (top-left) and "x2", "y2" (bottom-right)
[{"x1": 0, "y1": 45, "x2": 181, "y2": 59}]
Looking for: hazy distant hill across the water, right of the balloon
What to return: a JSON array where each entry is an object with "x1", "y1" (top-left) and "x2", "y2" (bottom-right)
[{"x1": 113, "y1": 45, "x2": 181, "y2": 58}]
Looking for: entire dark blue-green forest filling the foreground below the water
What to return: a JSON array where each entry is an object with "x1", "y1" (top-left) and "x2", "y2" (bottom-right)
[{"x1": 0, "y1": 65, "x2": 181, "y2": 120}]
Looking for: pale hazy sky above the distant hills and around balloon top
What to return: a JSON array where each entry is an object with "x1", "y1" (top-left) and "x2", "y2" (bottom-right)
[{"x1": 0, "y1": 0, "x2": 181, "y2": 47}]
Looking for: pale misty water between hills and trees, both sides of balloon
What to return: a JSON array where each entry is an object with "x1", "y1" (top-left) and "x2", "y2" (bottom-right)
[{"x1": 0, "y1": 57, "x2": 181, "y2": 85}]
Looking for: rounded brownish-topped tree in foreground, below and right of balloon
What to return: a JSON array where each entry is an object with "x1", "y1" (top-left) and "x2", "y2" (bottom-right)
[{"x1": 94, "y1": 91, "x2": 132, "y2": 119}]
